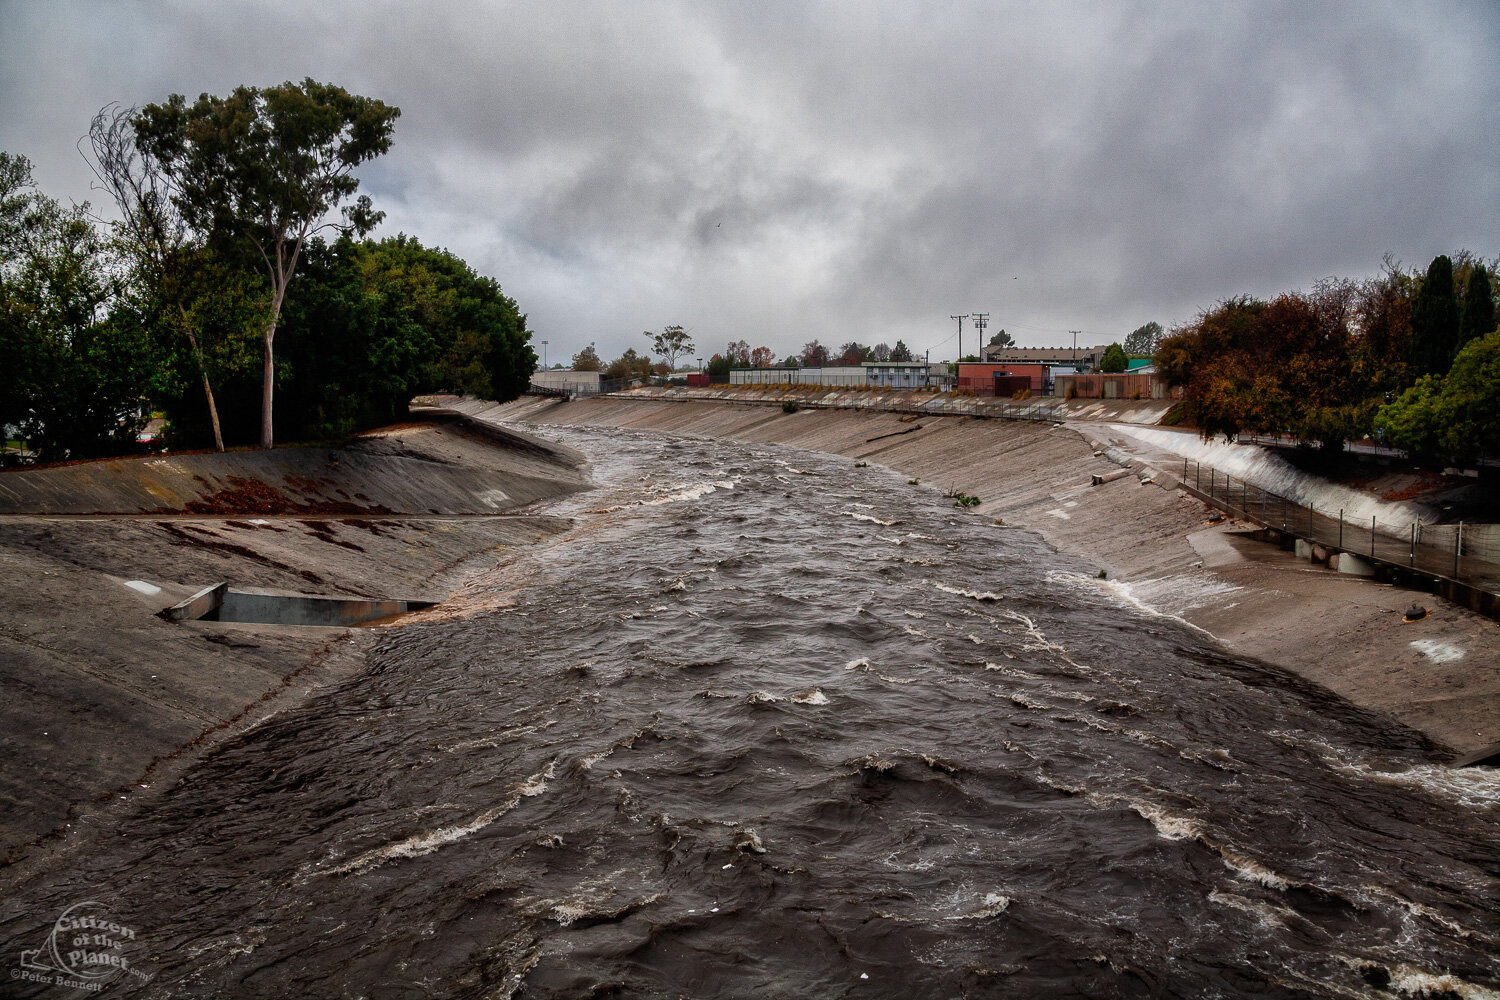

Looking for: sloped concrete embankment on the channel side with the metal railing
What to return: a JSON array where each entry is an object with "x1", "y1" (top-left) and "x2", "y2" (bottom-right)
[{"x1": 474, "y1": 397, "x2": 1500, "y2": 754}]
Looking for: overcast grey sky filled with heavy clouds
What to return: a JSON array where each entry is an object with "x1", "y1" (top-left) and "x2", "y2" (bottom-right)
[{"x1": 0, "y1": 0, "x2": 1500, "y2": 363}]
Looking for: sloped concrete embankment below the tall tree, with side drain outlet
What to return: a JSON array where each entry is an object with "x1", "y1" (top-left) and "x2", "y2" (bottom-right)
[{"x1": 0, "y1": 417, "x2": 587, "y2": 859}]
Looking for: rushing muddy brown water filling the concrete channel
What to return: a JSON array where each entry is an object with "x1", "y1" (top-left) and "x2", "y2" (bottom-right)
[{"x1": 0, "y1": 429, "x2": 1500, "y2": 997}]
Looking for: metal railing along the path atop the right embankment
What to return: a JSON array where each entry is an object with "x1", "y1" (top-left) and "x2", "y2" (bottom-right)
[{"x1": 1182, "y1": 459, "x2": 1500, "y2": 592}]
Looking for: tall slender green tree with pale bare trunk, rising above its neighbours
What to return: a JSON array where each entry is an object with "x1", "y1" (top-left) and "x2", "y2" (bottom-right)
[{"x1": 134, "y1": 78, "x2": 401, "y2": 448}]
